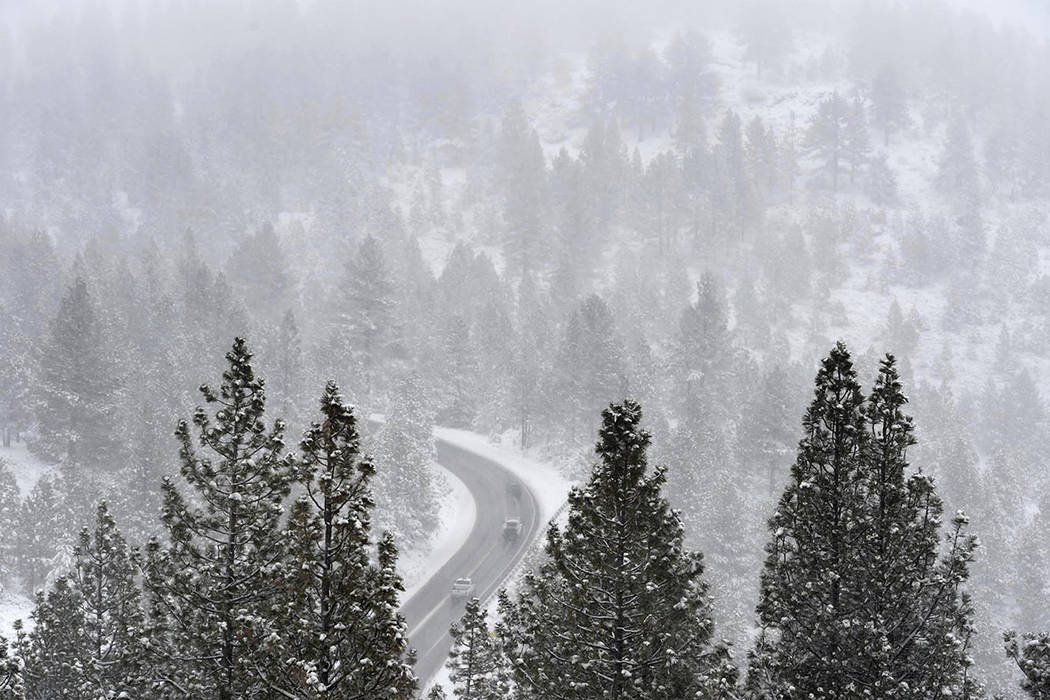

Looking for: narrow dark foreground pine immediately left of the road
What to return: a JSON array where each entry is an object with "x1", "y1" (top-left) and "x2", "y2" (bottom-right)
[{"x1": 259, "y1": 382, "x2": 417, "y2": 700}]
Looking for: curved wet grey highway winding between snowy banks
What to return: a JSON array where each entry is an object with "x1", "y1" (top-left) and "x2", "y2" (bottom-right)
[{"x1": 401, "y1": 440, "x2": 540, "y2": 688}]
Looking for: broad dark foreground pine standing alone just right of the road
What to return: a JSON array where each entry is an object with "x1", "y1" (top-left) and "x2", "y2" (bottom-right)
[{"x1": 500, "y1": 401, "x2": 736, "y2": 700}]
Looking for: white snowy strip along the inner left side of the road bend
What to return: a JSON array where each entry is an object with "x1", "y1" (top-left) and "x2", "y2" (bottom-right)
[{"x1": 398, "y1": 464, "x2": 477, "y2": 601}]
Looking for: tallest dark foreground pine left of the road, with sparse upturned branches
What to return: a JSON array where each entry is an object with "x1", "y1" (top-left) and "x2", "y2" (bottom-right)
[{"x1": 145, "y1": 338, "x2": 292, "y2": 700}]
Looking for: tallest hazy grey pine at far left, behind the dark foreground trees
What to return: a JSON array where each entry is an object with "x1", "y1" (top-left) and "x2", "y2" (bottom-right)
[{"x1": 30, "y1": 278, "x2": 122, "y2": 470}]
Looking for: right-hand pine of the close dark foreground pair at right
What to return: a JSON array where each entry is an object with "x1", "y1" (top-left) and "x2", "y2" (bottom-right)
[{"x1": 848, "y1": 355, "x2": 980, "y2": 700}]
